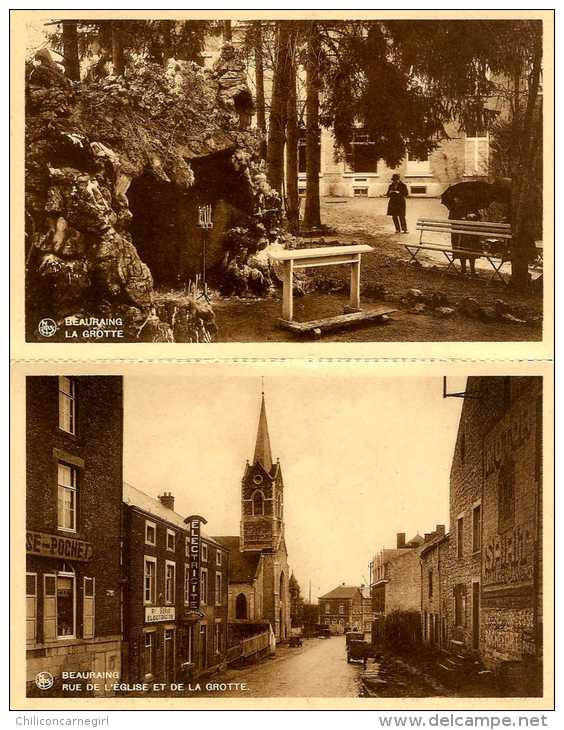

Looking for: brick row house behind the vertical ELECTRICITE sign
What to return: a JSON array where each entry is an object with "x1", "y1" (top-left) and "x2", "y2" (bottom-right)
[{"x1": 123, "y1": 484, "x2": 229, "y2": 684}]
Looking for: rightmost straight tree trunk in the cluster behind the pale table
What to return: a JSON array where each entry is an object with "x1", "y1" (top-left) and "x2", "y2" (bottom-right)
[{"x1": 304, "y1": 23, "x2": 321, "y2": 228}]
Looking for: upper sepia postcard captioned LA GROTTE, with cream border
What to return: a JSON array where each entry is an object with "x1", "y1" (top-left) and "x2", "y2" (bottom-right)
[{"x1": 11, "y1": 10, "x2": 554, "y2": 359}]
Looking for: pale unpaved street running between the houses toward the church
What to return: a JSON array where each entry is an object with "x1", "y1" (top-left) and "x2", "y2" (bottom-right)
[{"x1": 198, "y1": 636, "x2": 363, "y2": 697}]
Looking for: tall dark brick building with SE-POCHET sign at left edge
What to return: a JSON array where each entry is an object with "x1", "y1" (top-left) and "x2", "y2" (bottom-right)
[{"x1": 26, "y1": 376, "x2": 123, "y2": 696}]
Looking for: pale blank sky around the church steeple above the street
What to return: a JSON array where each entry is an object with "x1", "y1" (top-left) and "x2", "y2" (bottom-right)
[{"x1": 124, "y1": 369, "x2": 464, "y2": 599}]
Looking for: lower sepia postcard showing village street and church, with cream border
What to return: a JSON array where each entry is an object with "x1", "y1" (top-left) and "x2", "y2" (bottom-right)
[{"x1": 11, "y1": 362, "x2": 554, "y2": 710}]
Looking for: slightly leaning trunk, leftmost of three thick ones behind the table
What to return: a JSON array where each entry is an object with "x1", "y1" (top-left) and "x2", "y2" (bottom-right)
[{"x1": 266, "y1": 20, "x2": 289, "y2": 195}]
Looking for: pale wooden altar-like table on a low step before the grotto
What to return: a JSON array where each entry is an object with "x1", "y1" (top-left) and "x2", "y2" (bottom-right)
[{"x1": 270, "y1": 244, "x2": 395, "y2": 336}]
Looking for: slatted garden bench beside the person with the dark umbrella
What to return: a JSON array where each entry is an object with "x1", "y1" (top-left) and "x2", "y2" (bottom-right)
[{"x1": 402, "y1": 218, "x2": 511, "y2": 284}]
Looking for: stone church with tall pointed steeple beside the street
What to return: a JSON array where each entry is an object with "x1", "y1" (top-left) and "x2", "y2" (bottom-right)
[{"x1": 215, "y1": 395, "x2": 291, "y2": 641}]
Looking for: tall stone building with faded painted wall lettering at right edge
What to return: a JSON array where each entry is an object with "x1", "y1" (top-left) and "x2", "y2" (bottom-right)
[{"x1": 447, "y1": 377, "x2": 542, "y2": 684}]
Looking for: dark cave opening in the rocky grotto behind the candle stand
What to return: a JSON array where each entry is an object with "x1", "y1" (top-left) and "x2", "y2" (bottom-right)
[{"x1": 127, "y1": 150, "x2": 253, "y2": 289}]
